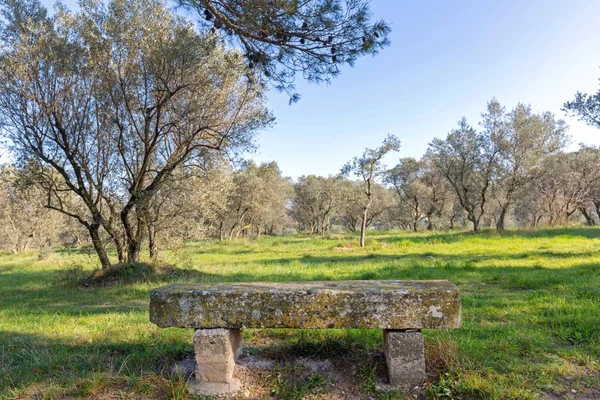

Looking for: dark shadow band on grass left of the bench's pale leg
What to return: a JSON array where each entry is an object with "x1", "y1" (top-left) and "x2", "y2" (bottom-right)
[{"x1": 0, "y1": 330, "x2": 191, "y2": 398}]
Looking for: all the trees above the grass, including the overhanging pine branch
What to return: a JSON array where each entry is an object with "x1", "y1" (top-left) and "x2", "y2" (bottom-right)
[{"x1": 0, "y1": 0, "x2": 600, "y2": 267}]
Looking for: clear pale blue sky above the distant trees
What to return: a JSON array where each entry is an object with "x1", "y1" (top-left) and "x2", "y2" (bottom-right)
[{"x1": 43, "y1": 0, "x2": 600, "y2": 178}]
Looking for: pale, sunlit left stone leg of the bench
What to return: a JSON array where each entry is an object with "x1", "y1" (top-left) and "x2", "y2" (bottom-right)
[{"x1": 194, "y1": 328, "x2": 242, "y2": 396}]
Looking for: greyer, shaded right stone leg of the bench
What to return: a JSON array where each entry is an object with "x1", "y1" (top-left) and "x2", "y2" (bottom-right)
[{"x1": 383, "y1": 329, "x2": 427, "y2": 387}]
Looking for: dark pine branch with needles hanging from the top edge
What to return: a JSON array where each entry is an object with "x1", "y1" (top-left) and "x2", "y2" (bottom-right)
[{"x1": 177, "y1": 0, "x2": 390, "y2": 101}]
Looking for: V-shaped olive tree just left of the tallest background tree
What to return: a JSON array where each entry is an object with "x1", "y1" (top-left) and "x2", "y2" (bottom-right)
[{"x1": 427, "y1": 109, "x2": 503, "y2": 231}]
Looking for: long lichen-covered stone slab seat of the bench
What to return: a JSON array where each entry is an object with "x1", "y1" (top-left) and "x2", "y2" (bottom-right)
[{"x1": 150, "y1": 280, "x2": 461, "y2": 329}]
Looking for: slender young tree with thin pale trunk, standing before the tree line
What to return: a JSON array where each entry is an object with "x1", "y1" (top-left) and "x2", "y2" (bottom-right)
[{"x1": 342, "y1": 135, "x2": 400, "y2": 247}]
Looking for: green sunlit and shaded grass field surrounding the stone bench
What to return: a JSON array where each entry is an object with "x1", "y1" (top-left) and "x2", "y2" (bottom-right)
[{"x1": 0, "y1": 228, "x2": 600, "y2": 399}]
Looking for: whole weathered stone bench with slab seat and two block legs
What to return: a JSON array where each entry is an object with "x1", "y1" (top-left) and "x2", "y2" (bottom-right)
[{"x1": 150, "y1": 280, "x2": 461, "y2": 395}]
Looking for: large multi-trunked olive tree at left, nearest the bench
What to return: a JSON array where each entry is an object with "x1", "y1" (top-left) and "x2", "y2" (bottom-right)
[{"x1": 0, "y1": 0, "x2": 271, "y2": 267}]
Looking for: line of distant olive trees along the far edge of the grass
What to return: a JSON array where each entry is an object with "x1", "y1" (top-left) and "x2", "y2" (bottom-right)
[{"x1": 7, "y1": 99, "x2": 600, "y2": 261}]
